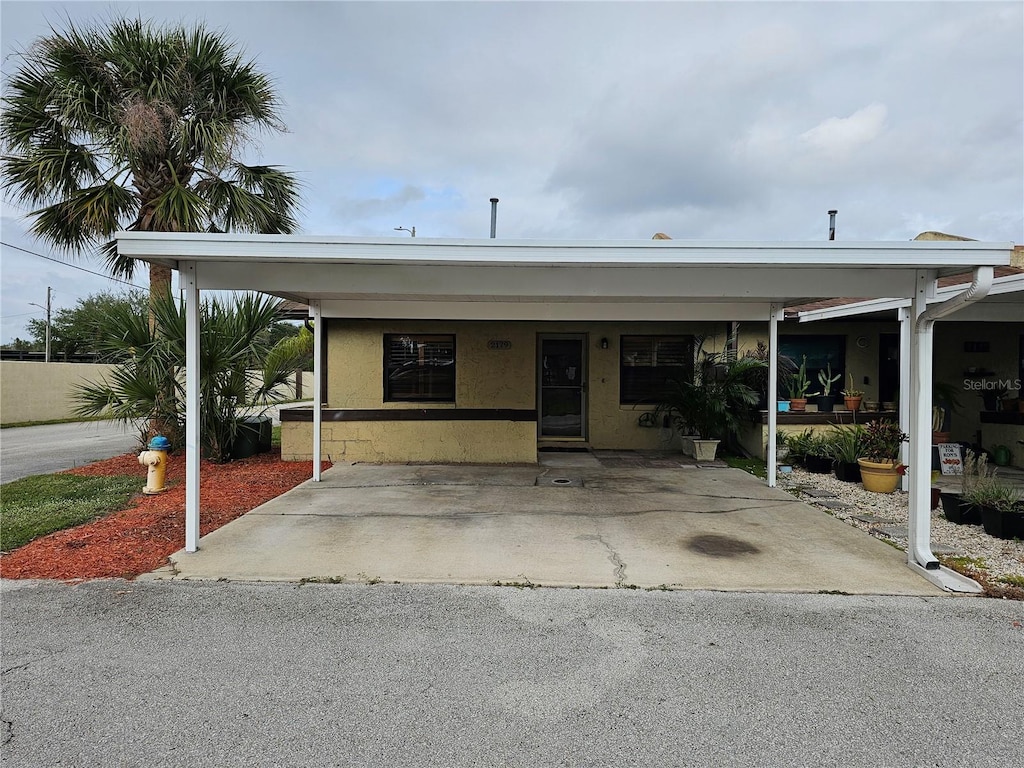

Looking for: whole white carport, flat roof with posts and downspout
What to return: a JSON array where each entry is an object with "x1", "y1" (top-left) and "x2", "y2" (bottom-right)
[{"x1": 117, "y1": 232, "x2": 1013, "y2": 591}]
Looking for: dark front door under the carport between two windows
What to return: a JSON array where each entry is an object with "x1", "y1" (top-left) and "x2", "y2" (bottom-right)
[{"x1": 537, "y1": 334, "x2": 587, "y2": 439}]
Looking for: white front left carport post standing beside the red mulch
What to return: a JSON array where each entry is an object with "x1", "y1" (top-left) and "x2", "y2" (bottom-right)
[{"x1": 178, "y1": 261, "x2": 200, "y2": 552}]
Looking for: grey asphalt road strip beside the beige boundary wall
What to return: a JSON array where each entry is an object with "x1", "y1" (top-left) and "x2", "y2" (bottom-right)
[{"x1": 0, "y1": 421, "x2": 140, "y2": 482}]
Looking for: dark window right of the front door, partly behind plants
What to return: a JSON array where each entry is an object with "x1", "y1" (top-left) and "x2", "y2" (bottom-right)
[{"x1": 618, "y1": 336, "x2": 693, "y2": 404}]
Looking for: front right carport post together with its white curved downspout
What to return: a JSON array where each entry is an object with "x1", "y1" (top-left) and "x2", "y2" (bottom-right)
[{"x1": 907, "y1": 266, "x2": 994, "y2": 591}]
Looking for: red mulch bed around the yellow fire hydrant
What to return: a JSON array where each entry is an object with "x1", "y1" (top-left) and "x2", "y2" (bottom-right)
[{"x1": 0, "y1": 449, "x2": 331, "y2": 582}]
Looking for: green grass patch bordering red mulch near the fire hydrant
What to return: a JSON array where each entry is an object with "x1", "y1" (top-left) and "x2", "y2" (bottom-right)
[{"x1": 0, "y1": 474, "x2": 145, "y2": 552}]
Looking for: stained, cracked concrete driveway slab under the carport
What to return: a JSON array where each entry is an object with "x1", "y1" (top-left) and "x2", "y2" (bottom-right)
[{"x1": 151, "y1": 465, "x2": 944, "y2": 595}]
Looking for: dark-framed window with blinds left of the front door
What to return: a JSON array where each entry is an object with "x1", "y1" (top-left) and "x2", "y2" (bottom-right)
[{"x1": 384, "y1": 334, "x2": 455, "y2": 402}]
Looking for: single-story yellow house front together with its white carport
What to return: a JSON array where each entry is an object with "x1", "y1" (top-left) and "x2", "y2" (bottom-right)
[{"x1": 118, "y1": 232, "x2": 1013, "y2": 583}]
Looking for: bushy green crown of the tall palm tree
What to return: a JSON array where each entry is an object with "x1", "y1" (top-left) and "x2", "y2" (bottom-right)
[{"x1": 0, "y1": 18, "x2": 298, "y2": 307}]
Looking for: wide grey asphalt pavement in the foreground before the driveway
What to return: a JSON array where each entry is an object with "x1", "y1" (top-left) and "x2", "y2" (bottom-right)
[{"x1": 0, "y1": 582, "x2": 1024, "y2": 768}]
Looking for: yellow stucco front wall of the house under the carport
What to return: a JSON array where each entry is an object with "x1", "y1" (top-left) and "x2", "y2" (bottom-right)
[{"x1": 282, "y1": 319, "x2": 726, "y2": 463}]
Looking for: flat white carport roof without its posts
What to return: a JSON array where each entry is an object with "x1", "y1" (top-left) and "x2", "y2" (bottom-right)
[{"x1": 118, "y1": 232, "x2": 1012, "y2": 321}]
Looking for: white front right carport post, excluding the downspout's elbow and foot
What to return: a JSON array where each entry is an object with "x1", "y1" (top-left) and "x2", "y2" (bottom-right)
[{"x1": 900, "y1": 269, "x2": 939, "y2": 570}]
